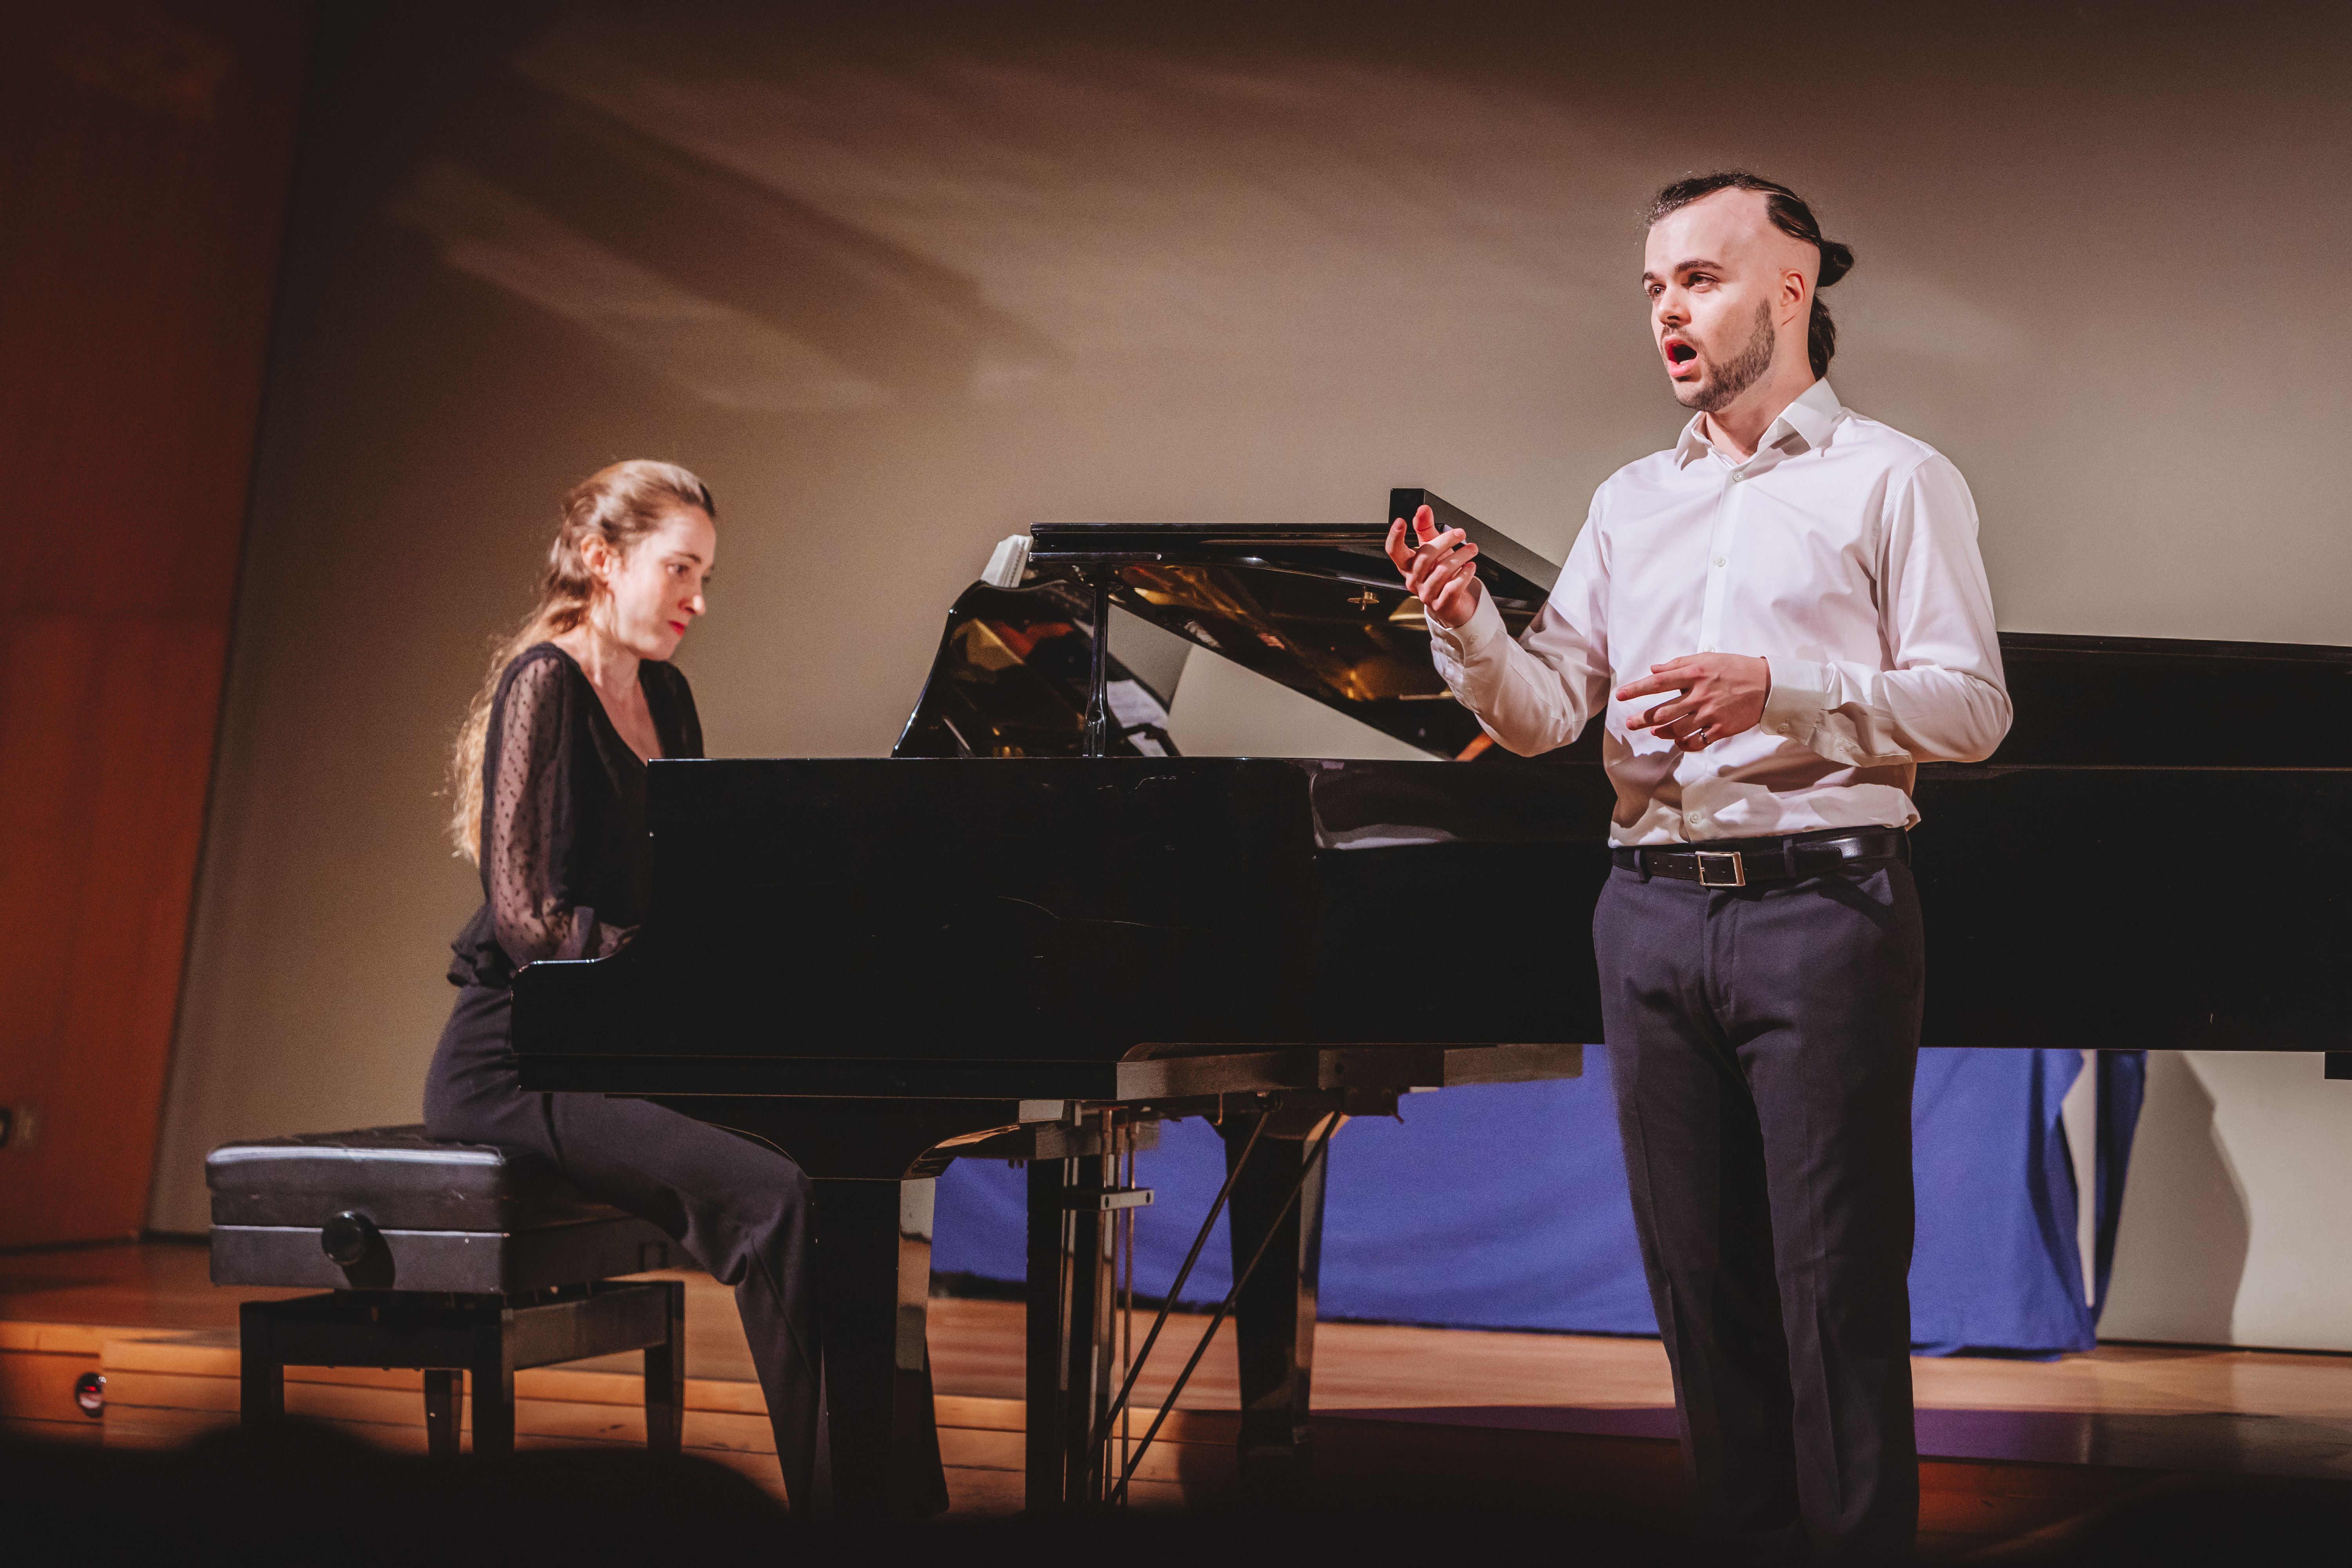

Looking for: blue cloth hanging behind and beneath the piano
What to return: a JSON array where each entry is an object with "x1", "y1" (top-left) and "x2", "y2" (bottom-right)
[{"x1": 934, "y1": 1046, "x2": 2143, "y2": 1356}]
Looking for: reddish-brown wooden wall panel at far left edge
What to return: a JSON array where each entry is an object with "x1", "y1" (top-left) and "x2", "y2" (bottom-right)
[{"x1": 0, "y1": 0, "x2": 310, "y2": 1246}]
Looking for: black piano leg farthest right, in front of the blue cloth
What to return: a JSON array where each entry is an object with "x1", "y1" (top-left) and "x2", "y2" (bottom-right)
[{"x1": 1218, "y1": 1114, "x2": 1329, "y2": 1504}]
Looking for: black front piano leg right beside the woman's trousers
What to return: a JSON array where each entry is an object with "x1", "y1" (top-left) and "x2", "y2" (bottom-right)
[{"x1": 816, "y1": 1178, "x2": 948, "y2": 1519}]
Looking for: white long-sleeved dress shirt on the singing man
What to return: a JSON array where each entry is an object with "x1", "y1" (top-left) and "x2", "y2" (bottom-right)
[{"x1": 1430, "y1": 381, "x2": 2009, "y2": 844}]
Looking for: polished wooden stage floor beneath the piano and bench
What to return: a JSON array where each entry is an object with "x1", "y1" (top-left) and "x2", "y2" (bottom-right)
[{"x1": 0, "y1": 1241, "x2": 2352, "y2": 1556}]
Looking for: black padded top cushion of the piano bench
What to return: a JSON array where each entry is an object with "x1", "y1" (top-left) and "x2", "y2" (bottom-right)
[{"x1": 205, "y1": 1126, "x2": 621, "y2": 1232}]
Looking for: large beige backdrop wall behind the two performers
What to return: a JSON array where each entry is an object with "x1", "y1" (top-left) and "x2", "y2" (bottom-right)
[{"x1": 153, "y1": 5, "x2": 2352, "y2": 1347}]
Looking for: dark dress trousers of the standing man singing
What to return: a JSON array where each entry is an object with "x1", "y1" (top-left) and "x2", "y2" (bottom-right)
[{"x1": 1592, "y1": 860, "x2": 1924, "y2": 1563}]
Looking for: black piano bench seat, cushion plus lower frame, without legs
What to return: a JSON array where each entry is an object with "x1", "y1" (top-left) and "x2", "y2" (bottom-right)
[{"x1": 205, "y1": 1126, "x2": 684, "y2": 1295}]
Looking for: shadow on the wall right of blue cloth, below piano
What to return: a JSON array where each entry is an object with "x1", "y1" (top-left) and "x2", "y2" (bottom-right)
[{"x1": 2100, "y1": 1051, "x2": 2253, "y2": 1345}]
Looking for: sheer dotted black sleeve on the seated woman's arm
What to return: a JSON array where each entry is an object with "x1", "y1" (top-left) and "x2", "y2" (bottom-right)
[{"x1": 482, "y1": 658, "x2": 630, "y2": 969}]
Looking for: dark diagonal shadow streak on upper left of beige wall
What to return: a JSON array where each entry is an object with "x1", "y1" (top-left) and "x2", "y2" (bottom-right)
[{"x1": 390, "y1": 75, "x2": 1063, "y2": 414}]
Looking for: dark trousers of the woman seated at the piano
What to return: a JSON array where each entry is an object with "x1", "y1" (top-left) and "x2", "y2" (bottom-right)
[{"x1": 426, "y1": 985, "x2": 818, "y2": 1509}]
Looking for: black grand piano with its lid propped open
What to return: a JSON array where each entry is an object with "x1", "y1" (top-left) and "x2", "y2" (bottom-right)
[{"x1": 513, "y1": 489, "x2": 2352, "y2": 1514}]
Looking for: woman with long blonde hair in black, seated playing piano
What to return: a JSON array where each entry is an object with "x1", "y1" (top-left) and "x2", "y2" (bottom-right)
[{"x1": 426, "y1": 461, "x2": 913, "y2": 1507}]
